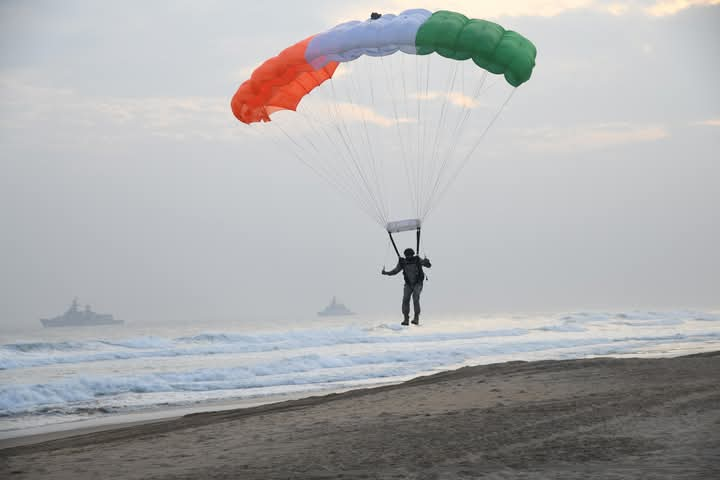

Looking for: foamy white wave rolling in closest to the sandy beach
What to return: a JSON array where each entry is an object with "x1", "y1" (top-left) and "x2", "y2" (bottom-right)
[{"x1": 0, "y1": 332, "x2": 720, "y2": 416}]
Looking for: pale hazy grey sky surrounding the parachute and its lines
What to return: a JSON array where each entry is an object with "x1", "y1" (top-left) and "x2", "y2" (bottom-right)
[{"x1": 0, "y1": 0, "x2": 720, "y2": 325}]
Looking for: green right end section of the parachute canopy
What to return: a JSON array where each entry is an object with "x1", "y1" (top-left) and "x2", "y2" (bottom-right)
[{"x1": 415, "y1": 10, "x2": 537, "y2": 87}]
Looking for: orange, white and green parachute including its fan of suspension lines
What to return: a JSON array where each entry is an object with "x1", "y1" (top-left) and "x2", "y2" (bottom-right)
[{"x1": 231, "y1": 9, "x2": 536, "y2": 251}]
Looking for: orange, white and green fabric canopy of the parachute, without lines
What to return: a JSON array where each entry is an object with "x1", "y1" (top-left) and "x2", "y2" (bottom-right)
[{"x1": 231, "y1": 9, "x2": 537, "y2": 123}]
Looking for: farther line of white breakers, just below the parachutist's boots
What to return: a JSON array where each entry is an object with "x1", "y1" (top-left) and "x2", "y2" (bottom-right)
[{"x1": 0, "y1": 310, "x2": 720, "y2": 370}]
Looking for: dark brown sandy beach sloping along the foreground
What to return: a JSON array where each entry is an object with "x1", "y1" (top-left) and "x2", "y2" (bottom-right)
[{"x1": 0, "y1": 352, "x2": 720, "y2": 479}]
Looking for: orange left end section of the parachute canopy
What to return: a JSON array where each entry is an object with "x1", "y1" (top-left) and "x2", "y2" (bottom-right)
[{"x1": 230, "y1": 37, "x2": 338, "y2": 123}]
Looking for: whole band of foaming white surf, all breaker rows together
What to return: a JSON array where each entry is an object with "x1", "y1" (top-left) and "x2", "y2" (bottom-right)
[{"x1": 0, "y1": 311, "x2": 720, "y2": 417}]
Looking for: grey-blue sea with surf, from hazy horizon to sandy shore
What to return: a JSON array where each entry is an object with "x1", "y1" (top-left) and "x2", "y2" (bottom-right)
[{"x1": 0, "y1": 310, "x2": 720, "y2": 440}]
